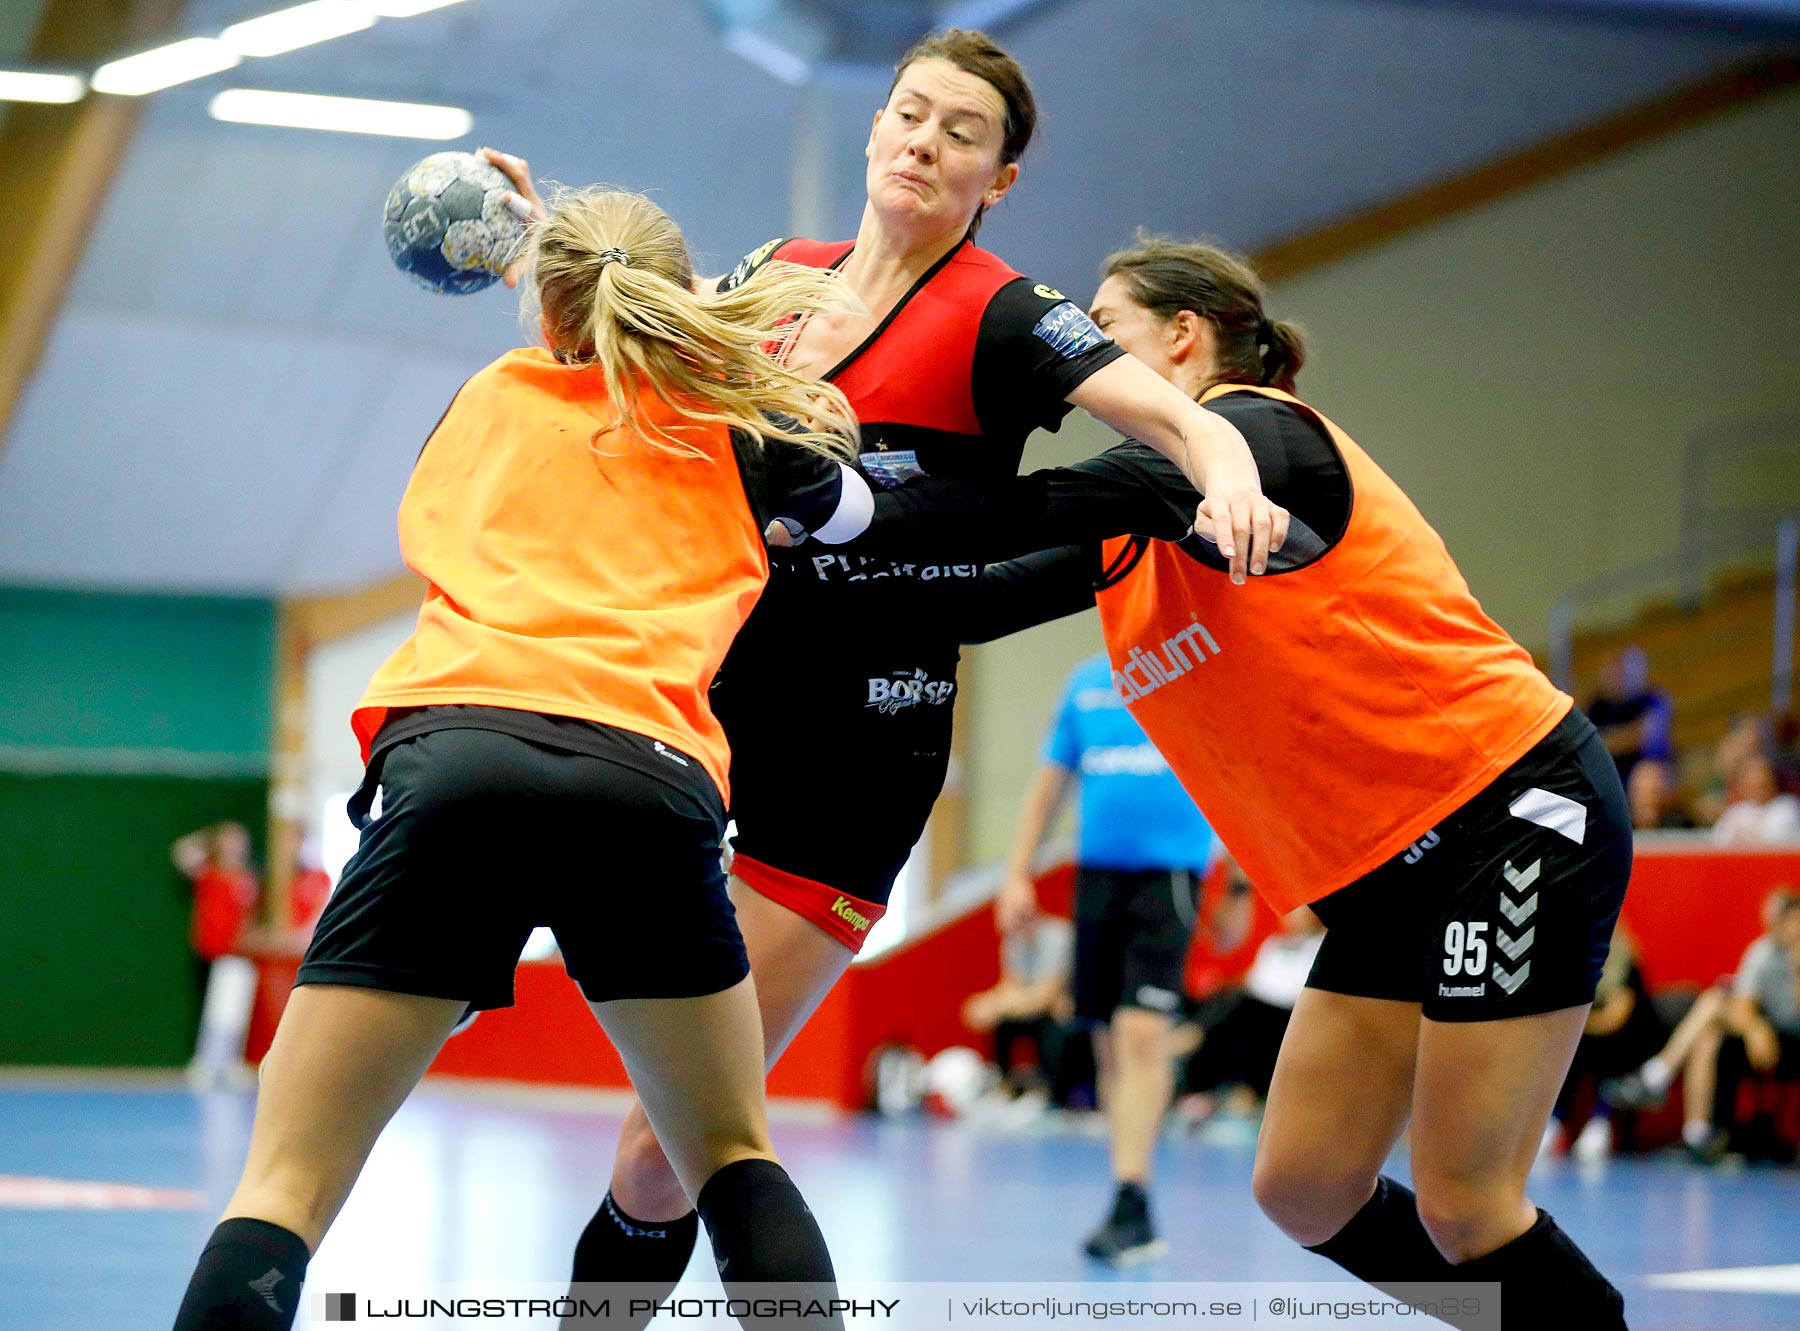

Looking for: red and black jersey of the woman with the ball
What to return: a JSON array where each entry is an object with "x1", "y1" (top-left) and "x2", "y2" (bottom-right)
[{"x1": 713, "y1": 240, "x2": 1125, "y2": 906}]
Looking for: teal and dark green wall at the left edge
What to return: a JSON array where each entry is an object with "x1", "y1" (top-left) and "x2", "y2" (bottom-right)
[{"x1": 0, "y1": 587, "x2": 275, "y2": 1066}]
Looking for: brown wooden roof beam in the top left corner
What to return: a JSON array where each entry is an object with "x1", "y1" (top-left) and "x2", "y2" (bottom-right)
[{"x1": 0, "y1": 0, "x2": 184, "y2": 468}]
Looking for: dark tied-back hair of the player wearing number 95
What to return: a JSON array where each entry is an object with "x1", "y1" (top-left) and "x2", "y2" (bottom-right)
[{"x1": 1100, "y1": 231, "x2": 1307, "y2": 393}]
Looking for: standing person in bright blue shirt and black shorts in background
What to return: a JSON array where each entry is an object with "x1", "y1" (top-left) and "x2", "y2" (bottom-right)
[{"x1": 997, "y1": 654, "x2": 1213, "y2": 1266}]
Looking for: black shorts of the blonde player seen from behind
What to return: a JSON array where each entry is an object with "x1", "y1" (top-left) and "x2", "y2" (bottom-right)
[{"x1": 297, "y1": 708, "x2": 749, "y2": 1010}]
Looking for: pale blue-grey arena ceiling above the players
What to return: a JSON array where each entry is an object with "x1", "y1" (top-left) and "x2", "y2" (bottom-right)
[{"x1": 0, "y1": 0, "x2": 1800, "y2": 594}]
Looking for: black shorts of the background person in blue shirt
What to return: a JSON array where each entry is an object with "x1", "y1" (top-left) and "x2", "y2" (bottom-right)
[{"x1": 1075, "y1": 866, "x2": 1201, "y2": 1023}]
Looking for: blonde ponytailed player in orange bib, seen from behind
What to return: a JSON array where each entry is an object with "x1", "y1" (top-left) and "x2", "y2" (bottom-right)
[{"x1": 175, "y1": 191, "x2": 869, "y2": 1331}]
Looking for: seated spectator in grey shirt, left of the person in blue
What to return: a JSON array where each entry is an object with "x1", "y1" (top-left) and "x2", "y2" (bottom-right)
[{"x1": 963, "y1": 911, "x2": 1075, "y2": 1104}]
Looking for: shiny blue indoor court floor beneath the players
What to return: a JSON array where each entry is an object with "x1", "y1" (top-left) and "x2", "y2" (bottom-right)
[{"x1": 0, "y1": 1079, "x2": 1800, "y2": 1331}]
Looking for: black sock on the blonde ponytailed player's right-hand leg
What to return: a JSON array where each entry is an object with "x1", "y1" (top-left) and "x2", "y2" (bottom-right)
[{"x1": 698, "y1": 1160, "x2": 842, "y2": 1331}]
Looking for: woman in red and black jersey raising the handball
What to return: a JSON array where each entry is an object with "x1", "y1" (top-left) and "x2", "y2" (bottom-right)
[{"x1": 486, "y1": 29, "x2": 1285, "y2": 1286}]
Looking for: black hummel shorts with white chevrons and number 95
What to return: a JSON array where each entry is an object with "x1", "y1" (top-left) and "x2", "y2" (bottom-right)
[{"x1": 1307, "y1": 711, "x2": 1631, "y2": 1021}]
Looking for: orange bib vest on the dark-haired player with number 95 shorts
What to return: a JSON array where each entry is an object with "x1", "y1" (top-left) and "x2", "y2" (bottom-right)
[{"x1": 1098, "y1": 384, "x2": 1573, "y2": 911}]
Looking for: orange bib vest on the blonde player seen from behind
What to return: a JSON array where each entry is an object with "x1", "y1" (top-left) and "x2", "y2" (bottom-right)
[{"x1": 351, "y1": 349, "x2": 769, "y2": 798}]
